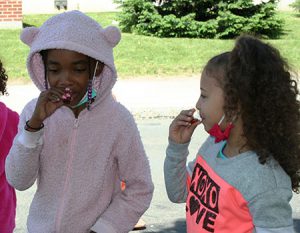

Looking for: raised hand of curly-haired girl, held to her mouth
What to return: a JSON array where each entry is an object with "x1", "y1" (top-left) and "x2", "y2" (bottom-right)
[{"x1": 169, "y1": 109, "x2": 201, "y2": 144}]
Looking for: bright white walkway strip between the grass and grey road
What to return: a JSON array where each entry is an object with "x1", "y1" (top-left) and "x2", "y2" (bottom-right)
[{"x1": 1, "y1": 77, "x2": 200, "y2": 118}]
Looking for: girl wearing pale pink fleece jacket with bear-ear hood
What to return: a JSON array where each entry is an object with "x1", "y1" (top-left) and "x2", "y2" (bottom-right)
[{"x1": 6, "y1": 11, "x2": 153, "y2": 233}]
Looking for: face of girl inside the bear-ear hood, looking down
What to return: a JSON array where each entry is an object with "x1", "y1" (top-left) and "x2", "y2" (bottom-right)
[{"x1": 46, "y1": 49, "x2": 99, "y2": 105}]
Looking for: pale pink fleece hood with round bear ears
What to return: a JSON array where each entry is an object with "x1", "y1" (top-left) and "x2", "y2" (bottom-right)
[{"x1": 20, "y1": 11, "x2": 121, "y2": 96}]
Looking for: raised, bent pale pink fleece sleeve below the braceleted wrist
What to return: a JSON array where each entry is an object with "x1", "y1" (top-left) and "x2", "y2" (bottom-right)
[{"x1": 5, "y1": 101, "x2": 43, "y2": 190}]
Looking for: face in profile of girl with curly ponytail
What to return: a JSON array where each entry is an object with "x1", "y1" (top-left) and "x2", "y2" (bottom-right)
[{"x1": 196, "y1": 72, "x2": 224, "y2": 131}]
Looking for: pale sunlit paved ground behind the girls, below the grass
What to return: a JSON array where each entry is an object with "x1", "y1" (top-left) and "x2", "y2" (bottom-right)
[{"x1": 1, "y1": 77, "x2": 300, "y2": 233}]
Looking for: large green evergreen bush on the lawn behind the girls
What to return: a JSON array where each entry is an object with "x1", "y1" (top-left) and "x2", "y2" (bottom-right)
[{"x1": 119, "y1": 0, "x2": 284, "y2": 38}]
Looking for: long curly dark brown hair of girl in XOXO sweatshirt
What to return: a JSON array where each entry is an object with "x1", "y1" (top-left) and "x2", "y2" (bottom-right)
[{"x1": 224, "y1": 35, "x2": 300, "y2": 193}]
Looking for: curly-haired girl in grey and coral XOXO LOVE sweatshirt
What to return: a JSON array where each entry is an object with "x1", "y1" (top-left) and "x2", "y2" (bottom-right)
[{"x1": 164, "y1": 36, "x2": 300, "y2": 233}]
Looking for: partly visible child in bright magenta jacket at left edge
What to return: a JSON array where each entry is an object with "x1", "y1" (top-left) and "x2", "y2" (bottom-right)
[{"x1": 0, "y1": 61, "x2": 19, "y2": 233}]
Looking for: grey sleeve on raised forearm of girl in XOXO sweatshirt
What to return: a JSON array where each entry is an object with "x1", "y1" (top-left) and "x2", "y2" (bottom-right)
[{"x1": 164, "y1": 140, "x2": 189, "y2": 203}]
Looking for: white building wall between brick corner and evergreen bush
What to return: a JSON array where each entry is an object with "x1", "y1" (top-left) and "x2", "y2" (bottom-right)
[{"x1": 22, "y1": 0, "x2": 118, "y2": 15}]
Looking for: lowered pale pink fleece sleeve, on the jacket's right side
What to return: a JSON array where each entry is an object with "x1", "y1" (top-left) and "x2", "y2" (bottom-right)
[{"x1": 91, "y1": 116, "x2": 154, "y2": 233}]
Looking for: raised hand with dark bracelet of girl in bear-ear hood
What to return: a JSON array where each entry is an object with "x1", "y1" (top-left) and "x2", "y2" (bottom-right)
[{"x1": 28, "y1": 88, "x2": 64, "y2": 128}]
